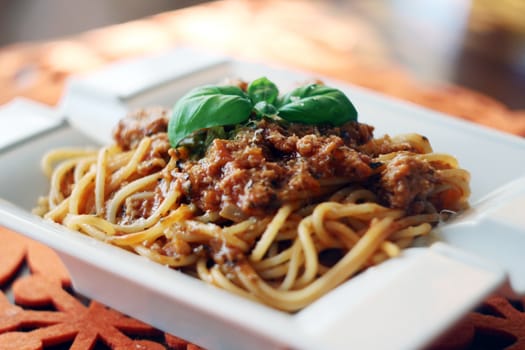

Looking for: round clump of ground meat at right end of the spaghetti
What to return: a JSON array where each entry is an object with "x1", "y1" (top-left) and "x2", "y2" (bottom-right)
[{"x1": 376, "y1": 152, "x2": 439, "y2": 213}]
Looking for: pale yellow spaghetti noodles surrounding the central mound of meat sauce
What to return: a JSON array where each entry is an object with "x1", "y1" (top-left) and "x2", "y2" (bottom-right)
[{"x1": 36, "y1": 104, "x2": 469, "y2": 312}]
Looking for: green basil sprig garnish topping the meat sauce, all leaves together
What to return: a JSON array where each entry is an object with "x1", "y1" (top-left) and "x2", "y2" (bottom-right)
[{"x1": 168, "y1": 77, "x2": 357, "y2": 150}]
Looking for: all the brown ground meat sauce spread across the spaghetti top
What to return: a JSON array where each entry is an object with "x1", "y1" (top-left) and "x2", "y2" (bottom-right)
[{"x1": 114, "y1": 109, "x2": 446, "y2": 216}]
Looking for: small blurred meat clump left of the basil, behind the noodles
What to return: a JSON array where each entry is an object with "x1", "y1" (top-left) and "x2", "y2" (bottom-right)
[{"x1": 113, "y1": 107, "x2": 169, "y2": 150}]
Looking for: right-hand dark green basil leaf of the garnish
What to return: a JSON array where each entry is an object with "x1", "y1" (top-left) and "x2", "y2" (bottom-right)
[{"x1": 278, "y1": 84, "x2": 357, "y2": 126}]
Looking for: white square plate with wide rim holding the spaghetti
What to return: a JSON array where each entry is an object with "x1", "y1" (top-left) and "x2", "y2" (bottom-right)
[{"x1": 0, "y1": 52, "x2": 525, "y2": 349}]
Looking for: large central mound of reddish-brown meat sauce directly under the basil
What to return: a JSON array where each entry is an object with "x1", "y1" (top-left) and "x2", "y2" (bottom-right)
[{"x1": 173, "y1": 120, "x2": 373, "y2": 216}]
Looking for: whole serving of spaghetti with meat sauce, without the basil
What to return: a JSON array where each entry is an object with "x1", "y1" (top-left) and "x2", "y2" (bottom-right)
[{"x1": 36, "y1": 85, "x2": 469, "y2": 312}]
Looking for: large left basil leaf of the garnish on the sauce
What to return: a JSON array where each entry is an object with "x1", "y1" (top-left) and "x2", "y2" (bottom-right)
[{"x1": 168, "y1": 86, "x2": 252, "y2": 147}]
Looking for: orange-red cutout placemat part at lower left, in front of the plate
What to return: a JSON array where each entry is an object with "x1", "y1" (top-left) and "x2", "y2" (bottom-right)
[{"x1": 0, "y1": 228, "x2": 199, "y2": 350}]
